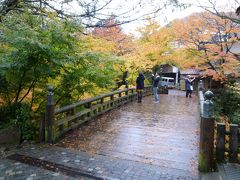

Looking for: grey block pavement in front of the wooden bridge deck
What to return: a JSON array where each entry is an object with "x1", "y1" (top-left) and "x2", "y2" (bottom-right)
[{"x1": 0, "y1": 145, "x2": 199, "y2": 180}]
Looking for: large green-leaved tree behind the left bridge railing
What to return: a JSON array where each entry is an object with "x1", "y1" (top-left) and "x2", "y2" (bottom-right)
[{"x1": 0, "y1": 9, "x2": 124, "y2": 139}]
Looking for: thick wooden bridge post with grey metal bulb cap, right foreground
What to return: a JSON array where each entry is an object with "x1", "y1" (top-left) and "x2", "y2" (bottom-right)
[{"x1": 199, "y1": 91, "x2": 215, "y2": 172}]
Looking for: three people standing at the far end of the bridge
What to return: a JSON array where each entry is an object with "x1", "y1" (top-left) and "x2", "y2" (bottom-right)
[{"x1": 136, "y1": 72, "x2": 195, "y2": 103}]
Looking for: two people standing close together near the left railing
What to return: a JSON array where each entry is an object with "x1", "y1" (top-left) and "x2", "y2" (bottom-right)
[{"x1": 136, "y1": 72, "x2": 160, "y2": 103}]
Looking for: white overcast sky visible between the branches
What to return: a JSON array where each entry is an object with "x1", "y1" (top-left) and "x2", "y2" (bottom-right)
[{"x1": 53, "y1": 0, "x2": 240, "y2": 34}]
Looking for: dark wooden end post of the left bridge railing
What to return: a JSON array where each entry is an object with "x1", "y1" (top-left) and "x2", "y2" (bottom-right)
[{"x1": 45, "y1": 86, "x2": 54, "y2": 143}]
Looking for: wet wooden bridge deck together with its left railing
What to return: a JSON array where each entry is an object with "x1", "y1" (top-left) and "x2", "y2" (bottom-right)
[{"x1": 28, "y1": 86, "x2": 200, "y2": 178}]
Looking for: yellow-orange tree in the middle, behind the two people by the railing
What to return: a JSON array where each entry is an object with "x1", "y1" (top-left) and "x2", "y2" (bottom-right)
[{"x1": 120, "y1": 18, "x2": 176, "y2": 83}]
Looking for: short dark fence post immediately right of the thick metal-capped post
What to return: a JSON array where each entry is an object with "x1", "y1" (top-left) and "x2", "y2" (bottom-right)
[{"x1": 216, "y1": 123, "x2": 226, "y2": 162}]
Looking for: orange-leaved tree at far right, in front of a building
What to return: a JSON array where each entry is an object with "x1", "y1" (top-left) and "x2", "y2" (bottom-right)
[{"x1": 172, "y1": 12, "x2": 239, "y2": 81}]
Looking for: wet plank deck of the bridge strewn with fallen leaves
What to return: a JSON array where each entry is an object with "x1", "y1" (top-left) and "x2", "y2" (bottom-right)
[{"x1": 57, "y1": 90, "x2": 199, "y2": 174}]
